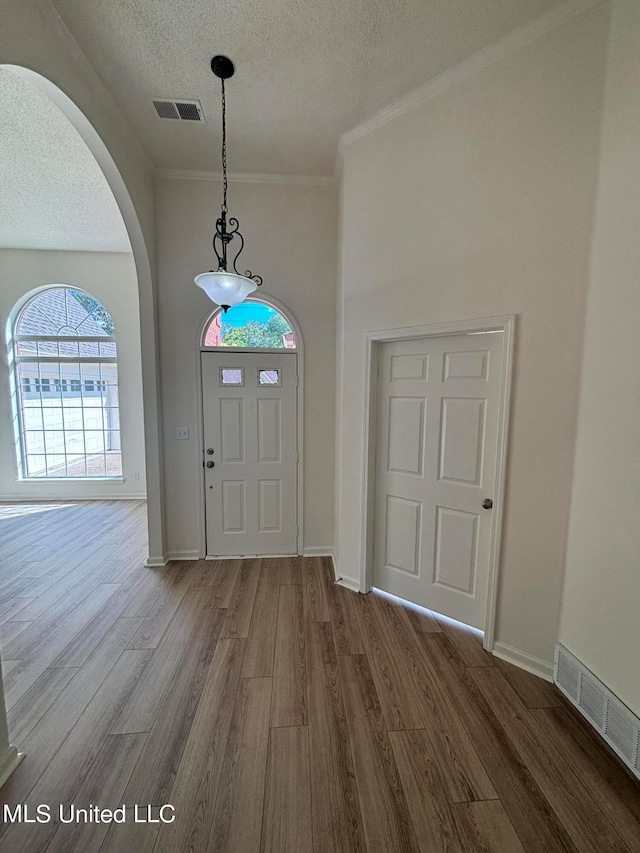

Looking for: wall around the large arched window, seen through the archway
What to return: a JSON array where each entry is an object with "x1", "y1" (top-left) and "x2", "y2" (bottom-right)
[{"x1": 0, "y1": 249, "x2": 146, "y2": 500}]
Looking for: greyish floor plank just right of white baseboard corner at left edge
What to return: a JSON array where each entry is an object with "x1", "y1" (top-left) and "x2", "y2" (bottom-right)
[{"x1": 0, "y1": 619, "x2": 140, "y2": 802}]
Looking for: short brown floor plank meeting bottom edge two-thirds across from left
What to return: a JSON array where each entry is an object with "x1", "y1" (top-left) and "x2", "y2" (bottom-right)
[{"x1": 389, "y1": 729, "x2": 468, "y2": 853}]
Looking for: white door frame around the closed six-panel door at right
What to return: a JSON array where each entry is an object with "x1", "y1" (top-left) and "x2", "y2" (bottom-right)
[{"x1": 360, "y1": 314, "x2": 516, "y2": 651}]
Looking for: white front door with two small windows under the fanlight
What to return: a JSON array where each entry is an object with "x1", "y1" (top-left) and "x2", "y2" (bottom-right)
[{"x1": 201, "y1": 351, "x2": 298, "y2": 557}]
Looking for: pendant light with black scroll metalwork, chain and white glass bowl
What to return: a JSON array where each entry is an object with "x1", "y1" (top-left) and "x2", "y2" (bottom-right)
[{"x1": 195, "y1": 56, "x2": 262, "y2": 314}]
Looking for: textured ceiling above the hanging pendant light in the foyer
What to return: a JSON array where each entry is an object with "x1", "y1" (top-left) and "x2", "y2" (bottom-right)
[{"x1": 50, "y1": 0, "x2": 559, "y2": 175}]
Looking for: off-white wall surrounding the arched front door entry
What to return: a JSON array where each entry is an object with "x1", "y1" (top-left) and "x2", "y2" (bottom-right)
[{"x1": 156, "y1": 178, "x2": 337, "y2": 556}]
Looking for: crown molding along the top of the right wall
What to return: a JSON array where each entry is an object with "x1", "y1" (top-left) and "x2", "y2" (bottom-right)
[{"x1": 335, "y1": 0, "x2": 602, "y2": 173}]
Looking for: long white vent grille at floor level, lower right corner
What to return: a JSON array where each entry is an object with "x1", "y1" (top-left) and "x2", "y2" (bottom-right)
[{"x1": 553, "y1": 643, "x2": 640, "y2": 779}]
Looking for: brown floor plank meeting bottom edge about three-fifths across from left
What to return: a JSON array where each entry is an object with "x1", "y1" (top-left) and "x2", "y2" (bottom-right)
[{"x1": 336, "y1": 655, "x2": 419, "y2": 853}]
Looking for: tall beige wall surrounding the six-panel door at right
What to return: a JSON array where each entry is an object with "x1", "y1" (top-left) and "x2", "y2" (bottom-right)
[{"x1": 337, "y1": 5, "x2": 608, "y2": 662}]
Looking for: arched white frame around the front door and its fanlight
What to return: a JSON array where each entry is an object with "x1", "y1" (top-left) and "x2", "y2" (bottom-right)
[{"x1": 195, "y1": 295, "x2": 304, "y2": 560}]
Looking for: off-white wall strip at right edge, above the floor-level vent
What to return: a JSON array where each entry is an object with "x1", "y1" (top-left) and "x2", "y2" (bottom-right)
[{"x1": 560, "y1": 0, "x2": 640, "y2": 715}]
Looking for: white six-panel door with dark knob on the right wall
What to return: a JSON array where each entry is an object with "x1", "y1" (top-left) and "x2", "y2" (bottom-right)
[{"x1": 373, "y1": 333, "x2": 504, "y2": 629}]
